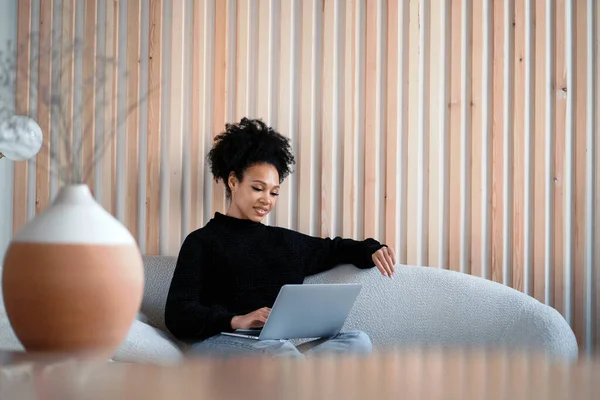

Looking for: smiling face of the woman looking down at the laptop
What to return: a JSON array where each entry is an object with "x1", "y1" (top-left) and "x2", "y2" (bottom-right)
[{"x1": 227, "y1": 163, "x2": 279, "y2": 222}]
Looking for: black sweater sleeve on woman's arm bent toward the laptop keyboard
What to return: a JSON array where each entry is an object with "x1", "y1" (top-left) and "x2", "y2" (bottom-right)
[{"x1": 165, "y1": 233, "x2": 235, "y2": 341}]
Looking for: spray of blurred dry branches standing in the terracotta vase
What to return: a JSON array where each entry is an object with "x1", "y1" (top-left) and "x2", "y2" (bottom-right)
[{"x1": 0, "y1": 32, "x2": 145, "y2": 184}]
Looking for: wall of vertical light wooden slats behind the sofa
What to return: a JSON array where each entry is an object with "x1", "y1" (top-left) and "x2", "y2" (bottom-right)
[{"x1": 13, "y1": 0, "x2": 600, "y2": 350}]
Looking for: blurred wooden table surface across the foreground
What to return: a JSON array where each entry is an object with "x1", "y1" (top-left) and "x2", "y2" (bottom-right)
[{"x1": 0, "y1": 350, "x2": 600, "y2": 400}]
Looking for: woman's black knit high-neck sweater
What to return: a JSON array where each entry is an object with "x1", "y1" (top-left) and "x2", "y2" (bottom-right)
[{"x1": 165, "y1": 213, "x2": 383, "y2": 342}]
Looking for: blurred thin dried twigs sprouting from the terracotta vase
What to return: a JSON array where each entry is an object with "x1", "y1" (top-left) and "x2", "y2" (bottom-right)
[{"x1": 0, "y1": 32, "x2": 135, "y2": 184}]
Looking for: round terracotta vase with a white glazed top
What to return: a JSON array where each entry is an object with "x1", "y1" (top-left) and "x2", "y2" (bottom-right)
[{"x1": 2, "y1": 185, "x2": 144, "y2": 355}]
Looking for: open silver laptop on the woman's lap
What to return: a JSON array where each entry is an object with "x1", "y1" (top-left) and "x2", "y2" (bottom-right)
[{"x1": 223, "y1": 283, "x2": 362, "y2": 340}]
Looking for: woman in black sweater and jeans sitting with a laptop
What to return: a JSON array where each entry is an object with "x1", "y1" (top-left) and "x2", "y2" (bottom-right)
[{"x1": 165, "y1": 118, "x2": 395, "y2": 357}]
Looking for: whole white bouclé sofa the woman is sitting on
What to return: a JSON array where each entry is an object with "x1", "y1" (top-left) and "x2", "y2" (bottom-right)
[{"x1": 0, "y1": 256, "x2": 578, "y2": 364}]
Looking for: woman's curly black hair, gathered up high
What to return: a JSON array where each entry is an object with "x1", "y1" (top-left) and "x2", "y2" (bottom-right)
[{"x1": 207, "y1": 118, "x2": 295, "y2": 197}]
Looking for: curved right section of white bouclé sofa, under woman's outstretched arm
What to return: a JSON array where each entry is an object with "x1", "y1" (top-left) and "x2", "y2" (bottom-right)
[{"x1": 305, "y1": 265, "x2": 577, "y2": 358}]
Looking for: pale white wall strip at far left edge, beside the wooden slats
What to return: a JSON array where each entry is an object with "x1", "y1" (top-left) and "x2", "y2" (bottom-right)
[{"x1": 0, "y1": 0, "x2": 18, "y2": 265}]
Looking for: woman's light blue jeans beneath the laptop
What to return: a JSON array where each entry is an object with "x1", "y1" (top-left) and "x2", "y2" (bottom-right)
[{"x1": 190, "y1": 331, "x2": 372, "y2": 358}]
